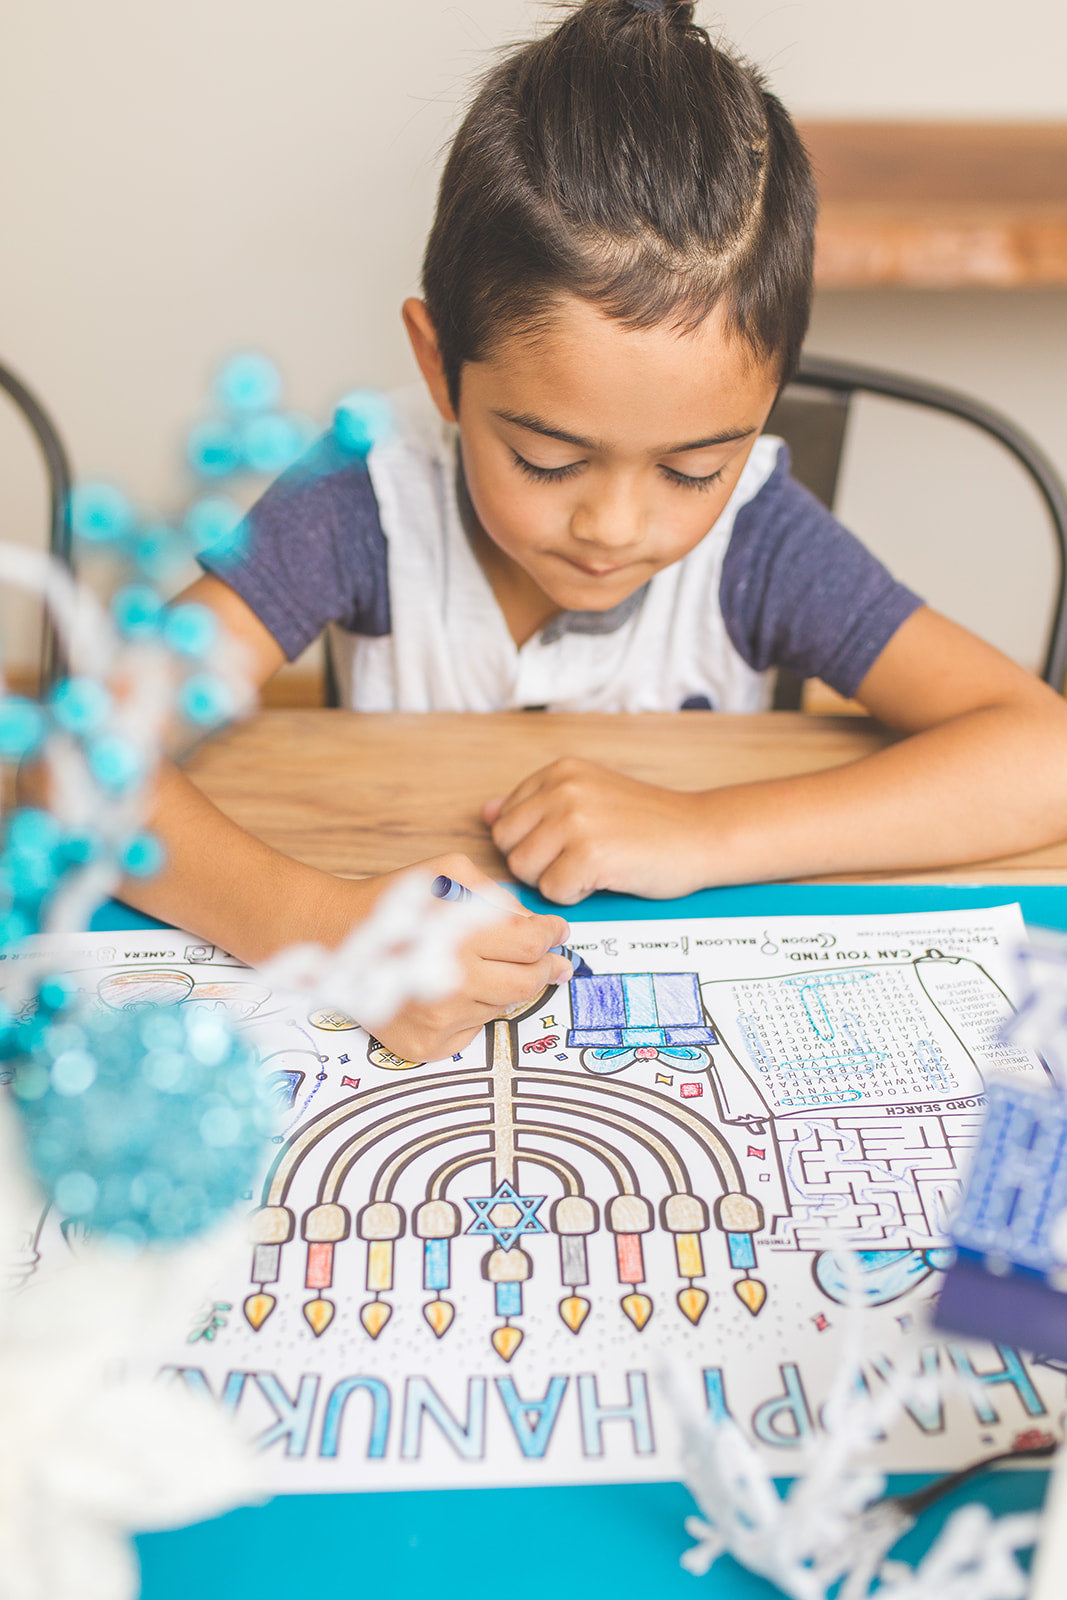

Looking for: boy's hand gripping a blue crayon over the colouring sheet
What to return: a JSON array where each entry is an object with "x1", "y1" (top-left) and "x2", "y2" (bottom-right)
[{"x1": 346, "y1": 854, "x2": 571, "y2": 1061}]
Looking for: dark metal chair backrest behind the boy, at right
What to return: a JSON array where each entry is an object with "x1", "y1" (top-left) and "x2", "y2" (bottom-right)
[{"x1": 766, "y1": 355, "x2": 1067, "y2": 710}]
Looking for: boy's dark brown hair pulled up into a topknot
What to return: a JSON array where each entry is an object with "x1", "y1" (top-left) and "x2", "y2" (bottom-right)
[{"x1": 422, "y1": 0, "x2": 816, "y2": 403}]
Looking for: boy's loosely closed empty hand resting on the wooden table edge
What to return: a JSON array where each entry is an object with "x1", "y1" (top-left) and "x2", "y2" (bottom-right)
[{"x1": 482, "y1": 757, "x2": 709, "y2": 906}]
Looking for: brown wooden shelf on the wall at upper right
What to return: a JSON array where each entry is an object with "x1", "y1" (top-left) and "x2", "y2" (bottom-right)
[{"x1": 801, "y1": 122, "x2": 1067, "y2": 290}]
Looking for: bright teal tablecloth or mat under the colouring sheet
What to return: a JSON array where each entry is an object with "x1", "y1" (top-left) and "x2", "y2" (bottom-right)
[{"x1": 116, "y1": 885, "x2": 1067, "y2": 1600}]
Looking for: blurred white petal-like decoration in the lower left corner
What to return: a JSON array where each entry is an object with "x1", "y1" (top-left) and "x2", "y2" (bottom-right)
[{"x1": 0, "y1": 1098, "x2": 259, "y2": 1600}]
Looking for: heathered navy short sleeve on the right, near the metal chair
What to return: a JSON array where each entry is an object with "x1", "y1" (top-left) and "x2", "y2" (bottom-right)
[{"x1": 720, "y1": 446, "x2": 923, "y2": 698}]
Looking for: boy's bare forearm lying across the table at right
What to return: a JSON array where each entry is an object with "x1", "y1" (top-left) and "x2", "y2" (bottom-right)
[{"x1": 697, "y1": 706, "x2": 1067, "y2": 883}]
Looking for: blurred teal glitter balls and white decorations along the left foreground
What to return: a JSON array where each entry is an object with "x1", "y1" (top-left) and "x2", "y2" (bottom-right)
[{"x1": 0, "y1": 355, "x2": 470, "y2": 1600}]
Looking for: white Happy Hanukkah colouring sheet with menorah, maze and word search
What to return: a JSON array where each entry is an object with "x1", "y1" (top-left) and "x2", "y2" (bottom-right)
[{"x1": 10, "y1": 906, "x2": 1065, "y2": 1491}]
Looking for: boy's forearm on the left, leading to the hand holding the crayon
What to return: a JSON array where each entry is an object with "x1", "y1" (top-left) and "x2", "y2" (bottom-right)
[{"x1": 118, "y1": 762, "x2": 361, "y2": 962}]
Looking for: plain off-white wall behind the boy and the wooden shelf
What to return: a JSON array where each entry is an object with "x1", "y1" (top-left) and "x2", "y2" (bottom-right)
[{"x1": 0, "y1": 0, "x2": 1067, "y2": 661}]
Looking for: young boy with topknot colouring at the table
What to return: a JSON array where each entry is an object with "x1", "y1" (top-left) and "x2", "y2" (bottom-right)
[{"x1": 112, "y1": 0, "x2": 1067, "y2": 1059}]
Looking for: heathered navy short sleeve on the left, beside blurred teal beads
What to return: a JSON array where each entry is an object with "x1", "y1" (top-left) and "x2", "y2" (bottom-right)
[{"x1": 200, "y1": 434, "x2": 390, "y2": 661}]
